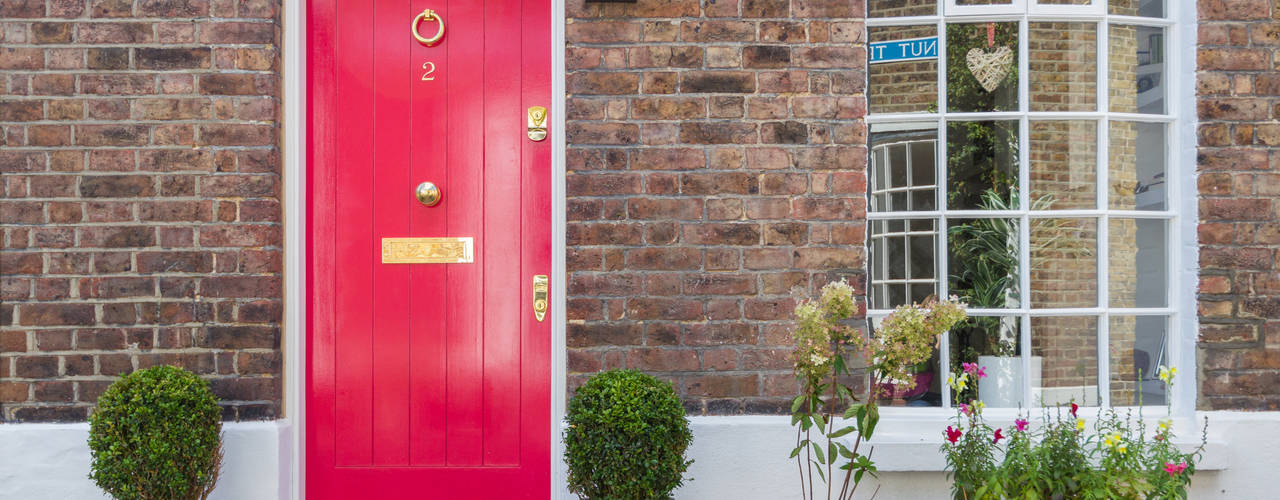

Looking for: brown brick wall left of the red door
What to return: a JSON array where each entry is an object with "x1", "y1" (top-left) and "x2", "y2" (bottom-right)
[{"x1": 0, "y1": 0, "x2": 282, "y2": 422}]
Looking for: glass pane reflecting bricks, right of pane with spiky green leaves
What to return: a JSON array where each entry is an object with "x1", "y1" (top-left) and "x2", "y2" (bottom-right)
[{"x1": 1030, "y1": 219, "x2": 1098, "y2": 308}]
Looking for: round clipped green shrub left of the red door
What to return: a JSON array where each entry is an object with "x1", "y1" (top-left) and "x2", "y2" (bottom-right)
[{"x1": 88, "y1": 366, "x2": 223, "y2": 500}]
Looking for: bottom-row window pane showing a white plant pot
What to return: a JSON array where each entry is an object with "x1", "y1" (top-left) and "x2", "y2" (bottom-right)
[{"x1": 950, "y1": 316, "x2": 1027, "y2": 408}]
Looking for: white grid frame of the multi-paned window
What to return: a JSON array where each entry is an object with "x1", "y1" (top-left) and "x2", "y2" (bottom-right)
[{"x1": 867, "y1": 0, "x2": 1198, "y2": 418}]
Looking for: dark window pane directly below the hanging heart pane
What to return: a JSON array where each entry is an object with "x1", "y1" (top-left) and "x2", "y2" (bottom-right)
[{"x1": 946, "y1": 121, "x2": 1018, "y2": 210}]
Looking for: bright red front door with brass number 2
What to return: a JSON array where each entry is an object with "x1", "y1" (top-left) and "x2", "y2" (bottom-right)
[{"x1": 306, "y1": 0, "x2": 556, "y2": 499}]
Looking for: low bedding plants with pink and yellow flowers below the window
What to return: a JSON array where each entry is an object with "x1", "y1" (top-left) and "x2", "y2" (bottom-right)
[{"x1": 942, "y1": 363, "x2": 1207, "y2": 500}]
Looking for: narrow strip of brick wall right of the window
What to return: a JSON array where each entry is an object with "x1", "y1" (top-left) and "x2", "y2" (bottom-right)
[{"x1": 1197, "y1": 0, "x2": 1280, "y2": 410}]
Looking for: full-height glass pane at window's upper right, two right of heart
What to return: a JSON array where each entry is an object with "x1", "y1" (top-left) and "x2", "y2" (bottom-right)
[{"x1": 1108, "y1": 24, "x2": 1165, "y2": 114}]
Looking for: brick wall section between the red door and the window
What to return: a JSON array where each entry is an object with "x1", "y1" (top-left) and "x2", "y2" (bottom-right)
[{"x1": 567, "y1": 0, "x2": 867, "y2": 414}]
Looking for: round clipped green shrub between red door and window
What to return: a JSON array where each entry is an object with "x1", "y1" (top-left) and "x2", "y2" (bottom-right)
[{"x1": 564, "y1": 370, "x2": 694, "y2": 500}]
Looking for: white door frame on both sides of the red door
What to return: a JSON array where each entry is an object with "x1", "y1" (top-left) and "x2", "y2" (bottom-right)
[{"x1": 280, "y1": 0, "x2": 566, "y2": 500}]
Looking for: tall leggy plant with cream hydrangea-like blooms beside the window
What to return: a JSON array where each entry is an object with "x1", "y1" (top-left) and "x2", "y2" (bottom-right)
[{"x1": 791, "y1": 281, "x2": 965, "y2": 500}]
